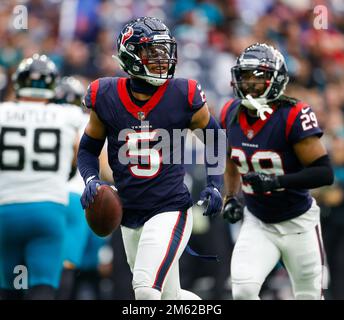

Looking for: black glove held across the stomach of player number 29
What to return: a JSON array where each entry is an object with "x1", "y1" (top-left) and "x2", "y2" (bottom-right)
[{"x1": 242, "y1": 172, "x2": 281, "y2": 193}]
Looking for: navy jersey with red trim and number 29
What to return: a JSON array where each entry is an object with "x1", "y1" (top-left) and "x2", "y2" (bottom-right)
[{"x1": 221, "y1": 99, "x2": 322, "y2": 223}]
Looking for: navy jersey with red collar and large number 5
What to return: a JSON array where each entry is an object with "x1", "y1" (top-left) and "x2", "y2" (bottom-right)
[{"x1": 84, "y1": 77, "x2": 205, "y2": 227}]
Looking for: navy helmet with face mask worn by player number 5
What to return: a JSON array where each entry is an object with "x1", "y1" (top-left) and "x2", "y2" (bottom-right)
[{"x1": 116, "y1": 17, "x2": 177, "y2": 86}]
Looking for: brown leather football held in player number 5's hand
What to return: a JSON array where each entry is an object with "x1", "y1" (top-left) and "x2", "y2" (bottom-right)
[{"x1": 85, "y1": 185, "x2": 122, "y2": 237}]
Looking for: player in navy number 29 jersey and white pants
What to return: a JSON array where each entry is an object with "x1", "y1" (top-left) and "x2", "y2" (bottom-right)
[{"x1": 221, "y1": 43, "x2": 333, "y2": 299}]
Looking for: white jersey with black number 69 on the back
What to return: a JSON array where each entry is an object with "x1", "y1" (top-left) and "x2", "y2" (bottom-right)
[{"x1": 0, "y1": 102, "x2": 82, "y2": 204}]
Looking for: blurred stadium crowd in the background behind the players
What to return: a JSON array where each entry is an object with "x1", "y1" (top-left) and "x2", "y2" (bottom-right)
[{"x1": 0, "y1": 0, "x2": 344, "y2": 299}]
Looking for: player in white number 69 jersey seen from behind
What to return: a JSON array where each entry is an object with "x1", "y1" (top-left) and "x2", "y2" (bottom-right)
[{"x1": 0, "y1": 54, "x2": 81, "y2": 299}]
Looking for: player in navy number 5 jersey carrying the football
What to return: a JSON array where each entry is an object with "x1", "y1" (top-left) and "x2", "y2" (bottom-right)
[{"x1": 78, "y1": 17, "x2": 224, "y2": 300}]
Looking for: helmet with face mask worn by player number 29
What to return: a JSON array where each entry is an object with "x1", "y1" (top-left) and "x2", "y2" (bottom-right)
[{"x1": 231, "y1": 43, "x2": 289, "y2": 103}]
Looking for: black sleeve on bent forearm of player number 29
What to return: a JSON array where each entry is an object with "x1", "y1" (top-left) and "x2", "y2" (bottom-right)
[{"x1": 277, "y1": 155, "x2": 334, "y2": 189}]
